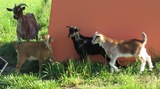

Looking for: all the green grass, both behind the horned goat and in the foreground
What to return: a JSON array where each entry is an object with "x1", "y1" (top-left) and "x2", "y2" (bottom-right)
[{"x1": 0, "y1": 0, "x2": 160, "y2": 89}]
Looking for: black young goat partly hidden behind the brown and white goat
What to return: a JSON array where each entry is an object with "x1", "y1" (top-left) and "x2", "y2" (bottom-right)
[{"x1": 66, "y1": 26, "x2": 120, "y2": 66}]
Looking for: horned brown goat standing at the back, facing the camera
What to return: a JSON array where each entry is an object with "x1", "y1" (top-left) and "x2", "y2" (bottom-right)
[{"x1": 7, "y1": 3, "x2": 38, "y2": 43}]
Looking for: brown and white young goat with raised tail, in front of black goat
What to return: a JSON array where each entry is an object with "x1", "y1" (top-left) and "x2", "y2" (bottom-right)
[{"x1": 92, "y1": 32, "x2": 153, "y2": 73}]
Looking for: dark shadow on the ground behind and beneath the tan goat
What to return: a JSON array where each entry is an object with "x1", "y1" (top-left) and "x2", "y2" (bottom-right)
[{"x1": 0, "y1": 42, "x2": 39, "y2": 74}]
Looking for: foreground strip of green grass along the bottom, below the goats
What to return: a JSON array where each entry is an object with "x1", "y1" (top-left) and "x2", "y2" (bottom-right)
[{"x1": 0, "y1": 60, "x2": 160, "y2": 89}]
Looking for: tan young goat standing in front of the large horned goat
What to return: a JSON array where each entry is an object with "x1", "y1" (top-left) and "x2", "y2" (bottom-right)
[{"x1": 15, "y1": 35, "x2": 53, "y2": 72}]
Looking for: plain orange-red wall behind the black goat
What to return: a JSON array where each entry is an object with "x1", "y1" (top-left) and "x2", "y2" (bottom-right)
[{"x1": 49, "y1": 0, "x2": 160, "y2": 61}]
